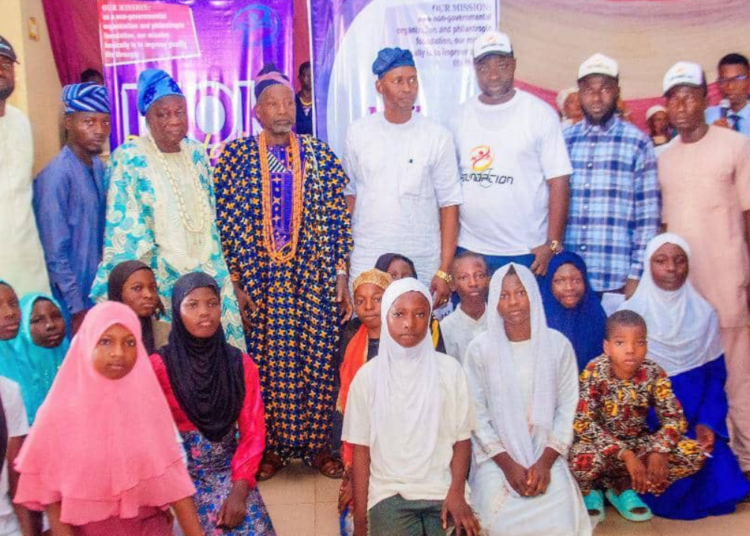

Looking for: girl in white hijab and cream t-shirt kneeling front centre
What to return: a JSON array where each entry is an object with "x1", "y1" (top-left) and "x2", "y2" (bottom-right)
[{"x1": 342, "y1": 278, "x2": 479, "y2": 536}]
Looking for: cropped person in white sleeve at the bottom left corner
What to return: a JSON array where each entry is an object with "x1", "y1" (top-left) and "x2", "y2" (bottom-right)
[{"x1": 0, "y1": 377, "x2": 29, "y2": 536}]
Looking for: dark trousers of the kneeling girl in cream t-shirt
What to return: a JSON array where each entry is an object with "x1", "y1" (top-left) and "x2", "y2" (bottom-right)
[{"x1": 367, "y1": 495, "x2": 451, "y2": 536}]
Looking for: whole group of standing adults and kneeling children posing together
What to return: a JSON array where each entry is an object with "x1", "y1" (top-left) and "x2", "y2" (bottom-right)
[{"x1": 0, "y1": 22, "x2": 750, "y2": 536}]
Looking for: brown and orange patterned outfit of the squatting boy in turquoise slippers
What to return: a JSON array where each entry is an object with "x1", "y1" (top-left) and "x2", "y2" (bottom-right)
[{"x1": 569, "y1": 355, "x2": 706, "y2": 493}]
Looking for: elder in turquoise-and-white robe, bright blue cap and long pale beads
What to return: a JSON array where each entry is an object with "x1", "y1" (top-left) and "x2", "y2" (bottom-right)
[{"x1": 91, "y1": 69, "x2": 245, "y2": 350}]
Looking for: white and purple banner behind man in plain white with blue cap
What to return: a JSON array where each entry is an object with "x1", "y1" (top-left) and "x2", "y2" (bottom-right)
[{"x1": 308, "y1": 0, "x2": 500, "y2": 154}]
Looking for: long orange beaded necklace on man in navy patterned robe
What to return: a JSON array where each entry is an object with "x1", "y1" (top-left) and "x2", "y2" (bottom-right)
[{"x1": 258, "y1": 131, "x2": 303, "y2": 264}]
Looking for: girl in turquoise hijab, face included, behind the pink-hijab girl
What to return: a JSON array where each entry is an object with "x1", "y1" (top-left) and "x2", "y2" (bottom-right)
[{"x1": 11, "y1": 294, "x2": 70, "y2": 424}]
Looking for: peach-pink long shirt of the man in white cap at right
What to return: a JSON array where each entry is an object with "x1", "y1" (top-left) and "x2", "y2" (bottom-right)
[{"x1": 658, "y1": 126, "x2": 750, "y2": 327}]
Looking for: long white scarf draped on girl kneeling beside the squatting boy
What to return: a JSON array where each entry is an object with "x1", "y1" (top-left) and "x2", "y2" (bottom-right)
[{"x1": 481, "y1": 263, "x2": 564, "y2": 467}]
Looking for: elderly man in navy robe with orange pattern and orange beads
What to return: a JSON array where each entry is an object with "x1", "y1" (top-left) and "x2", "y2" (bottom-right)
[{"x1": 215, "y1": 64, "x2": 351, "y2": 480}]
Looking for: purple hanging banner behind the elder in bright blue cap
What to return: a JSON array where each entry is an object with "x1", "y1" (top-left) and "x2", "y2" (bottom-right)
[{"x1": 99, "y1": 0, "x2": 293, "y2": 160}]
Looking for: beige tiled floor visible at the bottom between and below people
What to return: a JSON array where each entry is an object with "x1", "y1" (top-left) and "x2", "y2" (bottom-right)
[{"x1": 260, "y1": 463, "x2": 750, "y2": 536}]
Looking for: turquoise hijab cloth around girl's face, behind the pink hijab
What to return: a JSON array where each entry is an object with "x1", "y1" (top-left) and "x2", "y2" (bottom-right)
[{"x1": 12, "y1": 294, "x2": 70, "y2": 424}]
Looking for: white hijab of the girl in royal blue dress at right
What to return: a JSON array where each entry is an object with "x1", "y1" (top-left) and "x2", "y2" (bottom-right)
[{"x1": 620, "y1": 233, "x2": 724, "y2": 376}]
